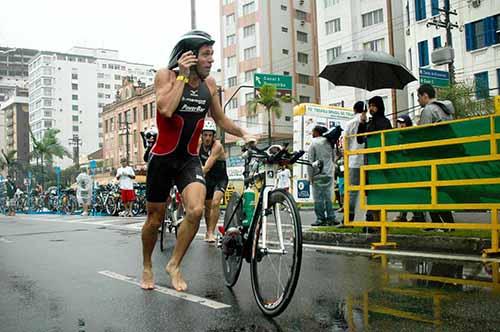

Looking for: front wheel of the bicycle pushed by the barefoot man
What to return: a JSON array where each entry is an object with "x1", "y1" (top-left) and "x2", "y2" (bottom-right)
[{"x1": 250, "y1": 190, "x2": 302, "y2": 316}]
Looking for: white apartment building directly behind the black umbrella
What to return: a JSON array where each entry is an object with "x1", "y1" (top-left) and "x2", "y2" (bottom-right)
[{"x1": 316, "y1": 0, "x2": 408, "y2": 119}]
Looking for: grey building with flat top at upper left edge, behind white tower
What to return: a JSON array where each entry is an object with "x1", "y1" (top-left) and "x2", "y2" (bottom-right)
[{"x1": 0, "y1": 47, "x2": 38, "y2": 105}]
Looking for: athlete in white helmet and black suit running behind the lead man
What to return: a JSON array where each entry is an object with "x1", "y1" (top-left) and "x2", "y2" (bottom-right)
[{"x1": 199, "y1": 118, "x2": 229, "y2": 243}]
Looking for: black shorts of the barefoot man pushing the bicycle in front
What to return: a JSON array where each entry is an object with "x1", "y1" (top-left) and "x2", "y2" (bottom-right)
[{"x1": 146, "y1": 154, "x2": 205, "y2": 203}]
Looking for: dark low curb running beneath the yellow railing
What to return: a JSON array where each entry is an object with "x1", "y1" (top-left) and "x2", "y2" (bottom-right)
[{"x1": 302, "y1": 231, "x2": 491, "y2": 255}]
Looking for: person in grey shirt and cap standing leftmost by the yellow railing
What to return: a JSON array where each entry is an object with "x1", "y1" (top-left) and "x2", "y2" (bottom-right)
[{"x1": 307, "y1": 125, "x2": 338, "y2": 226}]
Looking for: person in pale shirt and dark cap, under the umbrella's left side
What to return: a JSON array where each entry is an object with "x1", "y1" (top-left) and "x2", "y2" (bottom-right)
[{"x1": 344, "y1": 101, "x2": 365, "y2": 221}]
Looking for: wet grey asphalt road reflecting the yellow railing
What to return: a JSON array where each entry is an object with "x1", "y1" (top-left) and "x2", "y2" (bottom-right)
[{"x1": 0, "y1": 216, "x2": 500, "y2": 332}]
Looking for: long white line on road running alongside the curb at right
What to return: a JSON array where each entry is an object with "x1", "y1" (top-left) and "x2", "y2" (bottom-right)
[{"x1": 302, "y1": 244, "x2": 500, "y2": 262}]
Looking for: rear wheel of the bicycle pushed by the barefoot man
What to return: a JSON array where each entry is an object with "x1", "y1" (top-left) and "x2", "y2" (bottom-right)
[{"x1": 221, "y1": 192, "x2": 243, "y2": 287}]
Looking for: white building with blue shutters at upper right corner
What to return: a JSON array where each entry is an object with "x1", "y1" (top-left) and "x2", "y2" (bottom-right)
[{"x1": 403, "y1": 0, "x2": 500, "y2": 116}]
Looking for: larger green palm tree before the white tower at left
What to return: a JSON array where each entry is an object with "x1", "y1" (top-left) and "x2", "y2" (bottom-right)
[{"x1": 30, "y1": 128, "x2": 71, "y2": 187}]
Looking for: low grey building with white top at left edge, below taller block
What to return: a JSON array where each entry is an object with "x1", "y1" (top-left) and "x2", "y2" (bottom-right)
[{"x1": 0, "y1": 87, "x2": 30, "y2": 163}]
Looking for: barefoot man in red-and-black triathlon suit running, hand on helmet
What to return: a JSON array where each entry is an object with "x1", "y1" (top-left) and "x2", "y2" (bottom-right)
[{"x1": 141, "y1": 30, "x2": 255, "y2": 291}]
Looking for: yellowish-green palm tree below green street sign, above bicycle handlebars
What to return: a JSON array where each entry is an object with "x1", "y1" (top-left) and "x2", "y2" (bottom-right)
[{"x1": 247, "y1": 84, "x2": 296, "y2": 145}]
